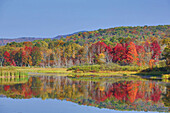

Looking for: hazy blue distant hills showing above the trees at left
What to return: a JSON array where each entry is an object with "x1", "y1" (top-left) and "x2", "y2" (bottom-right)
[{"x1": 0, "y1": 31, "x2": 86, "y2": 46}]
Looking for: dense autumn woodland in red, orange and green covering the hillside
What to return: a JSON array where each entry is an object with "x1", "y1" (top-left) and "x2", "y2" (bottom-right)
[{"x1": 0, "y1": 25, "x2": 170, "y2": 68}]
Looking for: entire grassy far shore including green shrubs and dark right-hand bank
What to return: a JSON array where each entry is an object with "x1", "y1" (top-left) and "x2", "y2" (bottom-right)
[{"x1": 0, "y1": 64, "x2": 169, "y2": 77}]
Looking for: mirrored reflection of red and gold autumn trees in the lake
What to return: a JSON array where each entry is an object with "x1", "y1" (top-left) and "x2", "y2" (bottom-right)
[{"x1": 0, "y1": 76, "x2": 170, "y2": 111}]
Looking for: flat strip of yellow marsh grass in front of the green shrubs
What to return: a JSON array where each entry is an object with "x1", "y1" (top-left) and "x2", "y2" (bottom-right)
[{"x1": 0, "y1": 67, "x2": 137, "y2": 76}]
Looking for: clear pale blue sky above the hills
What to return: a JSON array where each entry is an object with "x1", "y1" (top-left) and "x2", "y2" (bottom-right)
[{"x1": 0, "y1": 0, "x2": 170, "y2": 38}]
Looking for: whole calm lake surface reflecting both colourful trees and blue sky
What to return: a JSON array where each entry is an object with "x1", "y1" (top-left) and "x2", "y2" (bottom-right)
[{"x1": 0, "y1": 76, "x2": 170, "y2": 113}]
